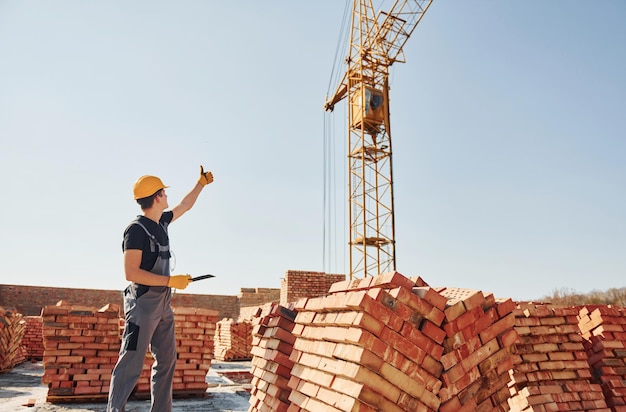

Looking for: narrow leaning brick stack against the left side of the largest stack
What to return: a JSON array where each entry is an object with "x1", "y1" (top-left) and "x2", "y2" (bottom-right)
[{"x1": 249, "y1": 304, "x2": 296, "y2": 412}]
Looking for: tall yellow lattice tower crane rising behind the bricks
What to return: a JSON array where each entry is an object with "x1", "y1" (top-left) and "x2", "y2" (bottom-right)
[{"x1": 324, "y1": 0, "x2": 432, "y2": 279}]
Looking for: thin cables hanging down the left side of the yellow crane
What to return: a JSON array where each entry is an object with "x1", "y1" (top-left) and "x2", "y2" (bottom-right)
[{"x1": 322, "y1": 0, "x2": 352, "y2": 273}]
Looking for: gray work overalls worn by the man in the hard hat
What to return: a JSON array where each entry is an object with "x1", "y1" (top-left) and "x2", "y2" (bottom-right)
[{"x1": 107, "y1": 221, "x2": 176, "y2": 412}]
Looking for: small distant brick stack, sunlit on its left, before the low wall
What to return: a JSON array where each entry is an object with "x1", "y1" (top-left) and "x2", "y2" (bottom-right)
[{"x1": 215, "y1": 318, "x2": 252, "y2": 361}]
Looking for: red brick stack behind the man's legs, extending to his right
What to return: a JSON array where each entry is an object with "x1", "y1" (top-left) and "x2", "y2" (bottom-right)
[{"x1": 134, "y1": 307, "x2": 218, "y2": 398}]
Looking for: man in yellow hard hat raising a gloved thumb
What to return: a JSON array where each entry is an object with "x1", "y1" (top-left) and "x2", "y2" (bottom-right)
[{"x1": 107, "y1": 166, "x2": 213, "y2": 412}]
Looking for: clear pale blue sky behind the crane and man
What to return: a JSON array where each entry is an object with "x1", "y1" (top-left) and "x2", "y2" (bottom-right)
[{"x1": 0, "y1": 0, "x2": 626, "y2": 300}]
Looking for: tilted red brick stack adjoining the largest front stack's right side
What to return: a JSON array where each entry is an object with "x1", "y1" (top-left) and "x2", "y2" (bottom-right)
[{"x1": 439, "y1": 288, "x2": 518, "y2": 412}]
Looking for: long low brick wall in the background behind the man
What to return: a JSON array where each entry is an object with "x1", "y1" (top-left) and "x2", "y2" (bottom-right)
[{"x1": 0, "y1": 285, "x2": 239, "y2": 319}]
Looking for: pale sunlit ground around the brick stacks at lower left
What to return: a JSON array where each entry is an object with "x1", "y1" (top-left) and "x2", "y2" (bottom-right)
[{"x1": 0, "y1": 361, "x2": 251, "y2": 412}]
